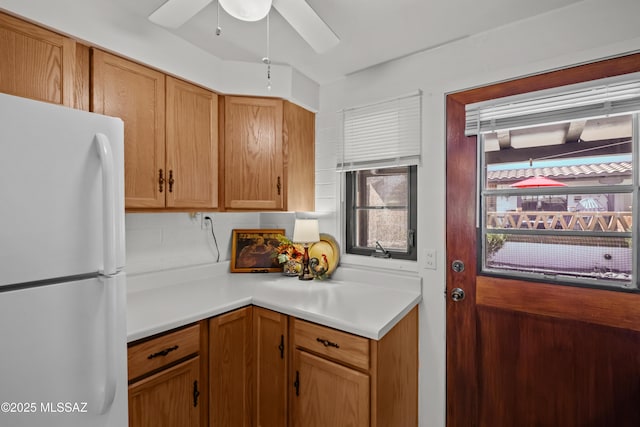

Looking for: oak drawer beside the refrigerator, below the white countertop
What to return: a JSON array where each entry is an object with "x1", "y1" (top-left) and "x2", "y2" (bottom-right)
[{"x1": 128, "y1": 324, "x2": 200, "y2": 380}]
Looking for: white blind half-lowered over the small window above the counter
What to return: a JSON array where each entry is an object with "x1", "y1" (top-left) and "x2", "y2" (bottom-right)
[{"x1": 337, "y1": 91, "x2": 422, "y2": 171}]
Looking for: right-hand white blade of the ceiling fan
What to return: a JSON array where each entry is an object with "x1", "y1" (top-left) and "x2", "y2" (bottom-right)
[{"x1": 272, "y1": 0, "x2": 340, "y2": 53}]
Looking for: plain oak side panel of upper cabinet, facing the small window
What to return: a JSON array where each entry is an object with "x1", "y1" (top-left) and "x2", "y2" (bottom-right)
[{"x1": 282, "y1": 101, "x2": 316, "y2": 211}]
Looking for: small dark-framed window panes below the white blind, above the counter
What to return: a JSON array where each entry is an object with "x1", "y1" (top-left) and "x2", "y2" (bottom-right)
[{"x1": 346, "y1": 166, "x2": 417, "y2": 260}]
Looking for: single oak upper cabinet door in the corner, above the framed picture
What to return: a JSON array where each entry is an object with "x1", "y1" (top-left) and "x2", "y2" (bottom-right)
[{"x1": 224, "y1": 96, "x2": 284, "y2": 210}]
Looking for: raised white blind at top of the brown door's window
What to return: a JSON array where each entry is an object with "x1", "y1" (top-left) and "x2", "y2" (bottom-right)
[{"x1": 465, "y1": 73, "x2": 640, "y2": 136}]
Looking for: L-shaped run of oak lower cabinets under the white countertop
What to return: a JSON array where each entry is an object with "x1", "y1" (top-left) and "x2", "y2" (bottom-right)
[{"x1": 129, "y1": 306, "x2": 418, "y2": 427}]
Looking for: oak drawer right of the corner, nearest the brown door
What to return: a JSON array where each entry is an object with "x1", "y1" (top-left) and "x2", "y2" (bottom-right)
[{"x1": 293, "y1": 319, "x2": 369, "y2": 370}]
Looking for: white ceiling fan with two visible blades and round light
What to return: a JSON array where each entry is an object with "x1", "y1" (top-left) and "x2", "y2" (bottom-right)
[{"x1": 149, "y1": 0, "x2": 340, "y2": 53}]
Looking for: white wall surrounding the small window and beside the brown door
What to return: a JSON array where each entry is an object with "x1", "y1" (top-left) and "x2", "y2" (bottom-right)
[{"x1": 316, "y1": 0, "x2": 640, "y2": 427}]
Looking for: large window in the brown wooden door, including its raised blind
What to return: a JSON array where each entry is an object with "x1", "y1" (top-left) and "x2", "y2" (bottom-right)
[{"x1": 467, "y1": 75, "x2": 640, "y2": 289}]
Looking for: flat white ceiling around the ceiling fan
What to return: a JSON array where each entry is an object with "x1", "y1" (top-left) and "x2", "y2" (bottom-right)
[{"x1": 109, "y1": 0, "x2": 582, "y2": 84}]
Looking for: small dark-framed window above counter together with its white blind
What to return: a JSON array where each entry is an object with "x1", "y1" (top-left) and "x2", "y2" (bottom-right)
[{"x1": 337, "y1": 93, "x2": 422, "y2": 260}]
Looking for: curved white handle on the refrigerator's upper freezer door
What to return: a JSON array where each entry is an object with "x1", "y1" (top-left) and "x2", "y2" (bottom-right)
[{"x1": 95, "y1": 133, "x2": 117, "y2": 276}]
